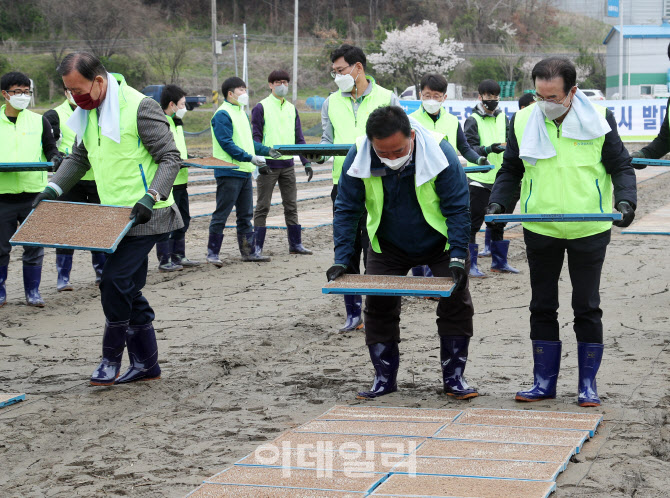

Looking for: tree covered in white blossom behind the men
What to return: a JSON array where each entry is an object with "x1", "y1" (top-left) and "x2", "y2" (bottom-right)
[{"x1": 368, "y1": 20, "x2": 463, "y2": 89}]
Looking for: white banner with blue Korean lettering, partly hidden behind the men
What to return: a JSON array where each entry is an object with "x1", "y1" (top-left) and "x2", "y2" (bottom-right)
[{"x1": 400, "y1": 99, "x2": 667, "y2": 141}]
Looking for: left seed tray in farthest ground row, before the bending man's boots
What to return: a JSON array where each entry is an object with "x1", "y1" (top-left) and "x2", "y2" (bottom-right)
[{"x1": 316, "y1": 405, "x2": 462, "y2": 424}]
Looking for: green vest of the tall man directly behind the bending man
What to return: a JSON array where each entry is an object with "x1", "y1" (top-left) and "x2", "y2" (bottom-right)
[{"x1": 328, "y1": 76, "x2": 393, "y2": 185}]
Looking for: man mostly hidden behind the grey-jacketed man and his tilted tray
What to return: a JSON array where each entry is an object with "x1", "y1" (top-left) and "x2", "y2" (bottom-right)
[{"x1": 44, "y1": 83, "x2": 106, "y2": 292}]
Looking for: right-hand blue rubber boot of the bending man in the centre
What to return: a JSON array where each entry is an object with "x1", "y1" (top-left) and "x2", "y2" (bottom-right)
[{"x1": 440, "y1": 335, "x2": 479, "y2": 399}]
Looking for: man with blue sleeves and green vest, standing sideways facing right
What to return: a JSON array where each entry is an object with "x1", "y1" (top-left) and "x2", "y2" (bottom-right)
[{"x1": 207, "y1": 76, "x2": 281, "y2": 267}]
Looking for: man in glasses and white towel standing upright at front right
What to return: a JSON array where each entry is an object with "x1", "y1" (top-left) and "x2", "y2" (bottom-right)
[{"x1": 487, "y1": 57, "x2": 637, "y2": 406}]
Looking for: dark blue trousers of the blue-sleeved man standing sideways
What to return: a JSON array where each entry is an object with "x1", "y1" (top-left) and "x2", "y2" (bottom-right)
[{"x1": 209, "y1": 175, "x2": 254, "y2": 234}]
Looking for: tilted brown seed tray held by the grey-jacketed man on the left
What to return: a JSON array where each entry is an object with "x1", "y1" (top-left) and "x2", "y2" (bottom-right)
[{"x1": 9, "y1": 201, "x2": 133, "y2": 253}]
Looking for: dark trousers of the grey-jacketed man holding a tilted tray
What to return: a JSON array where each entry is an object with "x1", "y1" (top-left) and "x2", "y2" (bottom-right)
[{"x1": 100, "y1": 234, "x2": 161, "y2": 325}]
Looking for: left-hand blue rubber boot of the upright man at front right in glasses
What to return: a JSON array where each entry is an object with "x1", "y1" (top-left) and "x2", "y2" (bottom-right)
[{"x1": 515, "y1": 341, "x2": 562, "y2": 401}]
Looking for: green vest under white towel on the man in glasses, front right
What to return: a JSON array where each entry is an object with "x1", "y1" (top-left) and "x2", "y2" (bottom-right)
[{"x1": 514, "y1": 105, "x2": 612, "y2": 239}]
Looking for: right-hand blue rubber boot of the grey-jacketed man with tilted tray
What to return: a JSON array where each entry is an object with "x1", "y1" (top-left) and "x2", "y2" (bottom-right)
[{"x1": 116, "y1": 323, "x2": 161, "y2": 384}]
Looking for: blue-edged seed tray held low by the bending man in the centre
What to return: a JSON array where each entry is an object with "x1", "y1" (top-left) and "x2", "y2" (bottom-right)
[{"x1": 322, "y1": 274, "x2": 454, "y2": 297}]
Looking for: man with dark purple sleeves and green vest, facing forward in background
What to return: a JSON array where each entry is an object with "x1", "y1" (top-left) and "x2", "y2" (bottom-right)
[{"x1": 251, "y1": 69, "x2": 313, "y2": 254}]
